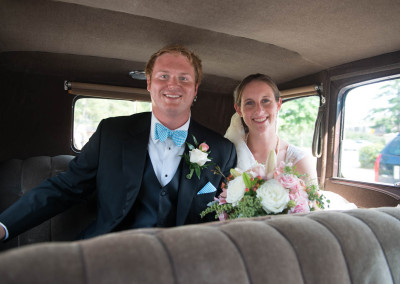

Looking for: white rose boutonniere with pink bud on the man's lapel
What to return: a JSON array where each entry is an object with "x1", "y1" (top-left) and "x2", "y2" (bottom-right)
[{"x1": 183, "y1": 135, "x2": 212, "y2": 179}]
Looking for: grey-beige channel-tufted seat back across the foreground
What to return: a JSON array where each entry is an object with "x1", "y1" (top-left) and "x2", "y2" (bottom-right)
[{"x1": 0, "y1": 207, "x2": 400, "y2": 284}]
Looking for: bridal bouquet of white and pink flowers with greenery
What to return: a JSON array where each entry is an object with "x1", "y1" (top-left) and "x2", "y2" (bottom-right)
[{"x1": 201, "y1": 151, "x2": 329, "y2": 221}]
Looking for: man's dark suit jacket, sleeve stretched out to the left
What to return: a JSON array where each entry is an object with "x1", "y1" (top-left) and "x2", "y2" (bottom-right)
[{"x1": 0, "y1": 113, "x2": 236, "y2": 238}]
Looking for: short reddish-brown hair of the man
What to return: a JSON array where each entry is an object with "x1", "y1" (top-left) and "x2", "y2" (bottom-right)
[{"x1": 145, "y1": 44, "x2": 203, "y2": 85}]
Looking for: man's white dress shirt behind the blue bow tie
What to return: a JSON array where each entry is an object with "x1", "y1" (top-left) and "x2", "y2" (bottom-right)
[{"x1": 149, "y1": 113, "x2": 190, "y2": 186}]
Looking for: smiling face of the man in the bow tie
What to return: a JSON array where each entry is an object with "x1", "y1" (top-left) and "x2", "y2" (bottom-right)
[{"x1": 147, "y1": 53, "x2": 198, "y2": 123}]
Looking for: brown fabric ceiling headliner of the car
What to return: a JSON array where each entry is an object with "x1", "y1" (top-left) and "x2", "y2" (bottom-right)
[{"x1": 0, "y1": 0, "x2": 400, "y2": 88}]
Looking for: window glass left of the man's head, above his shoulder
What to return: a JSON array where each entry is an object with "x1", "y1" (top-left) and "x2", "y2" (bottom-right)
[{"x1": 72, "y1": 98, "x2": 151, "y2": 151}]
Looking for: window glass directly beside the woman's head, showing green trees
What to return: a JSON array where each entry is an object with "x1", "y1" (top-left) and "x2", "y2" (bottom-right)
[{"x1": 278, "y1": 96, "x2": 320, "y2": 162}]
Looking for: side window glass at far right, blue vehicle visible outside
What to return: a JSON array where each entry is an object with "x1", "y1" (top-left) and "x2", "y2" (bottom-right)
[{"x1": 339, "y1": 79, "x2": 400, "y2": 184}]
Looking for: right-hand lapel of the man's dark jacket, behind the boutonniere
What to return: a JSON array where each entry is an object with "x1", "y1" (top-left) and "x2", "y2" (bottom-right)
[{"x1": 176, "y1": 120, "x2": 202, "y2": 226}]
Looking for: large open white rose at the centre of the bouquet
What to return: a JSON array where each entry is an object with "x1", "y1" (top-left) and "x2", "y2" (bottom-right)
[{"x1": 257, "y1": 179, "x2": 290, "y2": 213}]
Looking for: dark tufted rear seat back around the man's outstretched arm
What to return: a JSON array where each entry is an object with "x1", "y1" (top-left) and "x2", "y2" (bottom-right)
[{"x1": 0, "y1": 155, "x2": 96, "y2": 251}]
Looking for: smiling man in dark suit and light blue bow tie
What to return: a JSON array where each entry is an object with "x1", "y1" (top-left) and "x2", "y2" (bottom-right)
[{"x1": 0, "y1": 46, "x2": 236, "y2": 239}]
